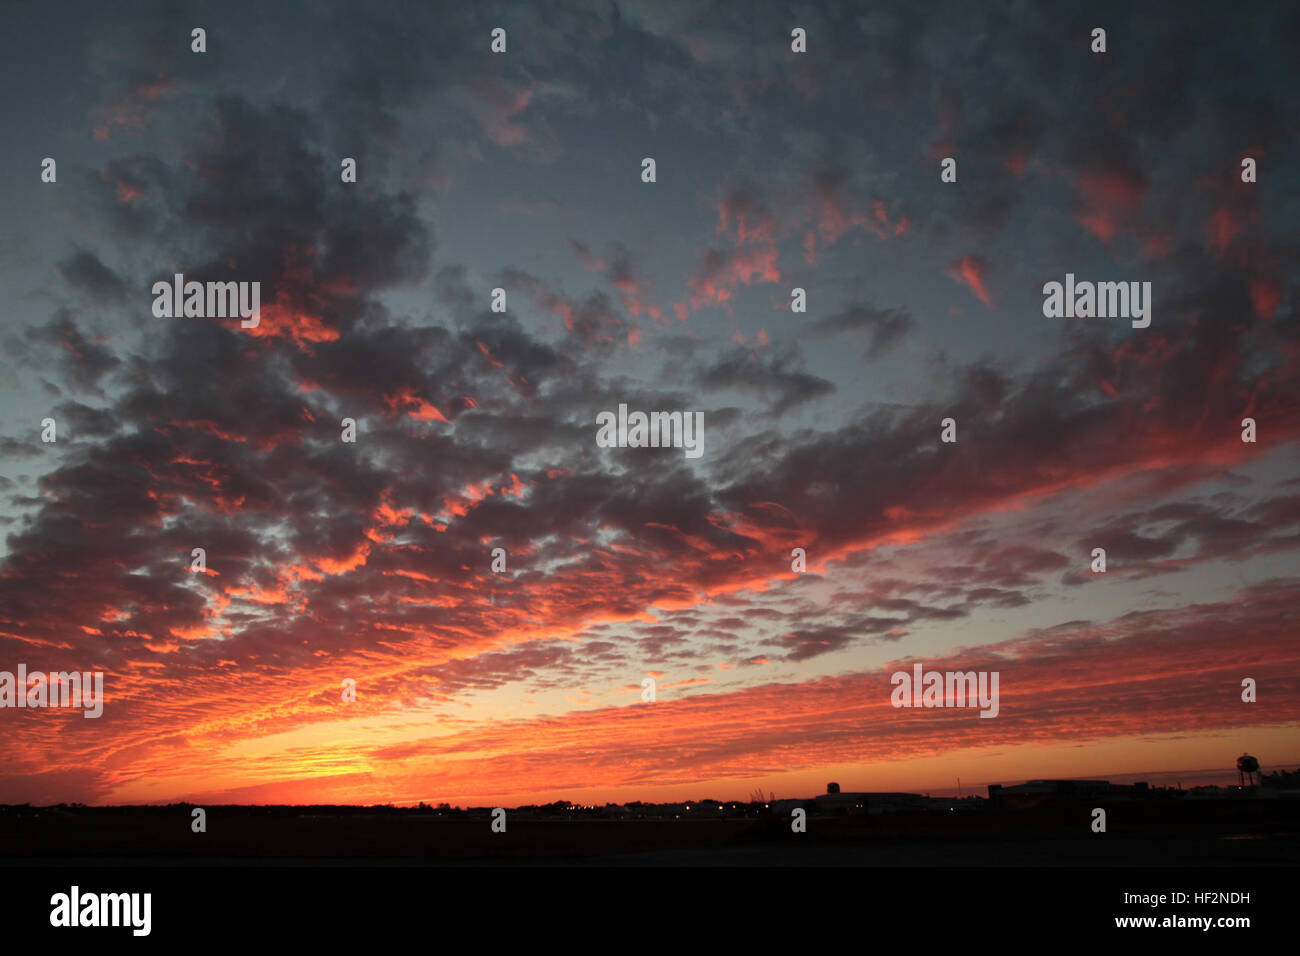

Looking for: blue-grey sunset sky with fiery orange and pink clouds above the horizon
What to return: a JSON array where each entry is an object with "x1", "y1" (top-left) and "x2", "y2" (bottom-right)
[{"x1": 0, "y1": 0, "x2": 1300, "y2": 806}]
